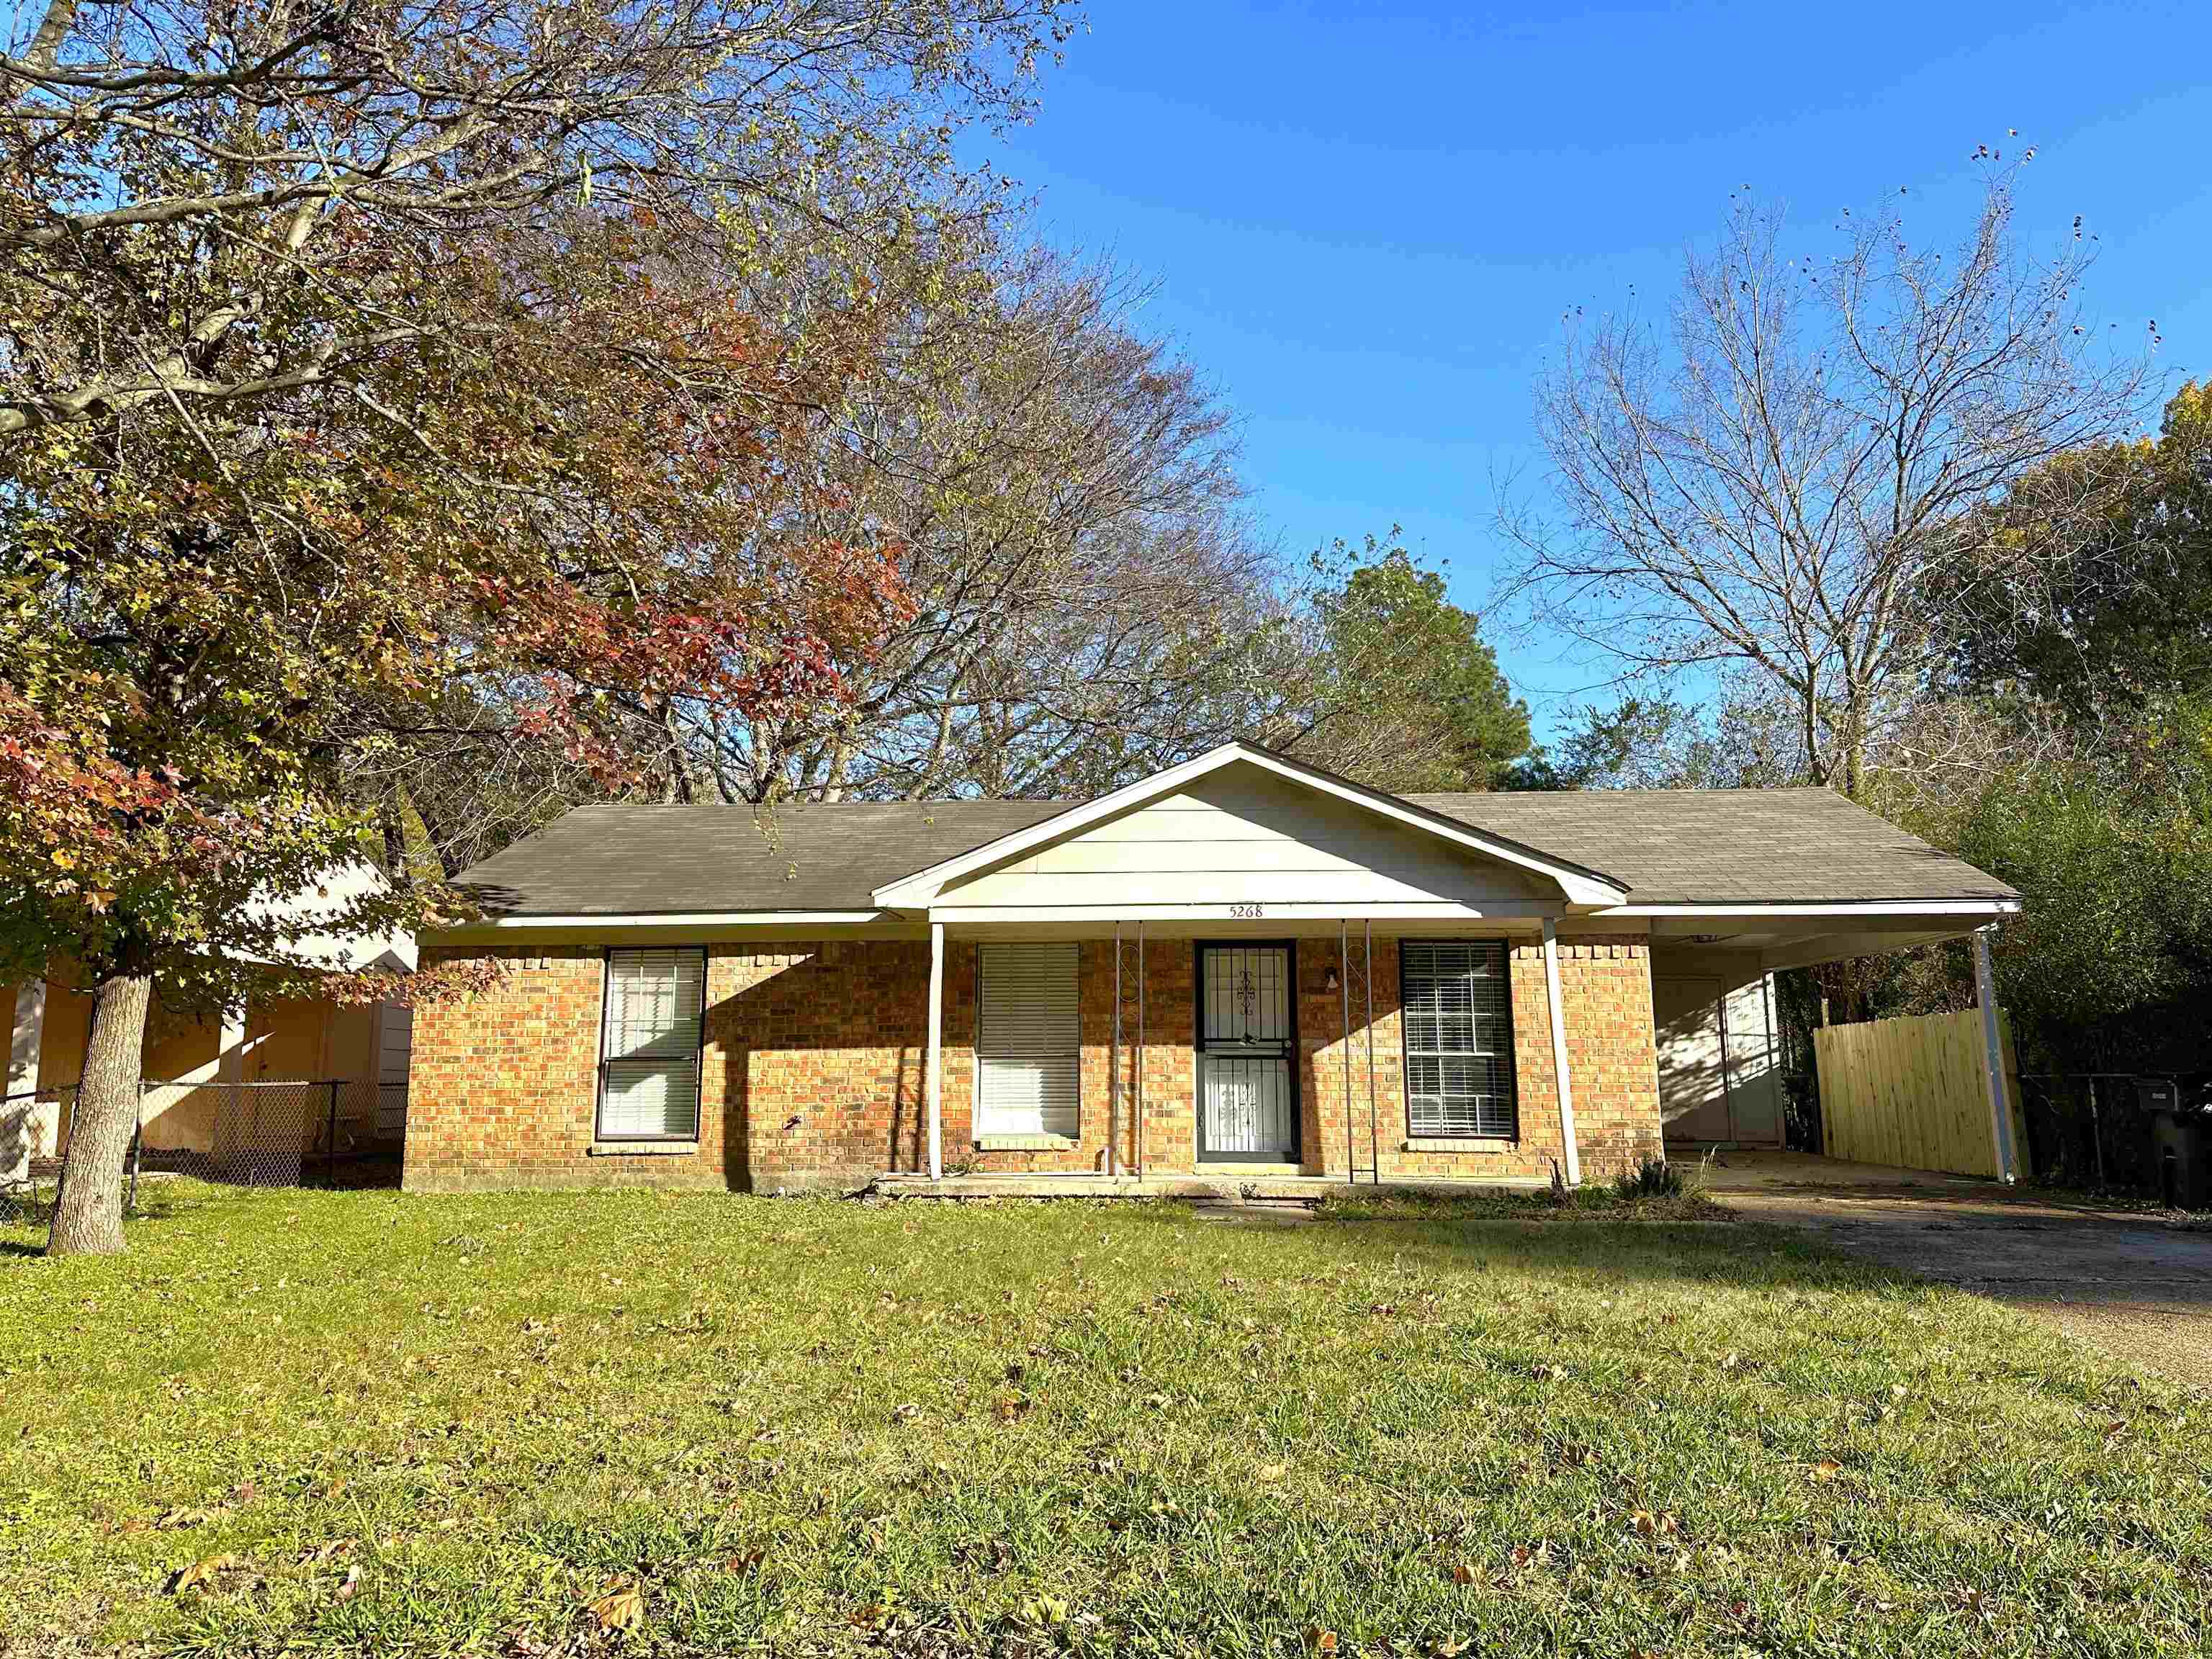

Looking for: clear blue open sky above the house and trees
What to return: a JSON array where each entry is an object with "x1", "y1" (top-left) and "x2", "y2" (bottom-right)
[{"x1": 974, "y1": 0, "x2": 2212, "y2": 732}]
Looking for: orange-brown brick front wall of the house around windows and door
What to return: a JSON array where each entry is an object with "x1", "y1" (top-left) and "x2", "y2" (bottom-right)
[{"x1": 405, "y1": 933, "x2": 1659, "y2": 1192}]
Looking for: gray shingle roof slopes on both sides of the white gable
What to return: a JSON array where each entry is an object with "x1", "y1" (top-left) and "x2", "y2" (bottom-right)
[{"x1": 462, "y1": 790, "x2": 2013, "y2": 916}]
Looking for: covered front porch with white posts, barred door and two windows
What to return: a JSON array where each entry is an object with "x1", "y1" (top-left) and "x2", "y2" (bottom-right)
[{"x1": 907, "y1": 916, "x2": 1659, "y2": 1197}]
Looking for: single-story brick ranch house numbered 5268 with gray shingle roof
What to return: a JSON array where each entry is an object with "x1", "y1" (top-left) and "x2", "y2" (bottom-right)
[{"x1": 405, "y1": 743, "x2": 2020, "y2": 1192}]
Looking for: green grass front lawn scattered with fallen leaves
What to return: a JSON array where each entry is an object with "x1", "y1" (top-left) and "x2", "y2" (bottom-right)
[{"x1": 0, "y1": 1186, "x2": 2212, "y2": 1657}]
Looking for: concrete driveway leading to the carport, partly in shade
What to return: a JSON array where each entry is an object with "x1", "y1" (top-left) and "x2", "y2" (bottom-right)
[{"x1": 1712, "y1": 1153, "x2": 2212, "y2": 1389}]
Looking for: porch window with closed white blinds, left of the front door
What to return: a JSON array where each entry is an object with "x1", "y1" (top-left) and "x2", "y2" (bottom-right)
[{"x1": 976, "y1": 945, "x2": 1082, "y2": 1139}]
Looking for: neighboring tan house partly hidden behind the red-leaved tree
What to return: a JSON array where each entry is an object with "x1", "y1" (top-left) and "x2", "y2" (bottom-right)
[{"x1": 0, "y1": 865, "x2": 416, "y2": 1172}]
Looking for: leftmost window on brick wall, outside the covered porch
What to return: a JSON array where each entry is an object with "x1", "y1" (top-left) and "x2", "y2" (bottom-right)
[{"x1": 597, "y1": 949, "x2": 706, "y2": 1141}]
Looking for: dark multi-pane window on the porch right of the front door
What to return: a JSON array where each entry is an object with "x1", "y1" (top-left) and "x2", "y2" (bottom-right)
[{"x1": 1398, "y1": 940, "x2": 1517, "y2": 1137}]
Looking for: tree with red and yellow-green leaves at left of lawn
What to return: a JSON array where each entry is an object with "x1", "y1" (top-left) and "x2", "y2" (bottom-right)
[{"x1": 0, "y1": 0, "x2": 1066, "y2": 1254}]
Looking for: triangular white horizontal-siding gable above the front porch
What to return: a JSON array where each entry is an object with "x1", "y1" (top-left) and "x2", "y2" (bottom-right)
[{"x1": 938, "y1": 765, "x2": 1560, "y2": 909}]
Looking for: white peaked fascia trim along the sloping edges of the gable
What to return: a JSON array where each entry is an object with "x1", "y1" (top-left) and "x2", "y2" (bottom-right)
[{"x1": 869, "y1": 743, "x2": 1628, "y2": 914}]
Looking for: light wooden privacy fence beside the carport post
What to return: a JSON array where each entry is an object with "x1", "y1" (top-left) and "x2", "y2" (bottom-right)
[{"x1": 1812, "y1": 1009, "x2": 2028, "y2": 1177}]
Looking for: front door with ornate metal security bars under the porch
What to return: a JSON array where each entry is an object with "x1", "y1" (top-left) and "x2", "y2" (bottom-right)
[{"x1": 1197, "y1": 943, "x2": 1298, "y2": 1164}]
